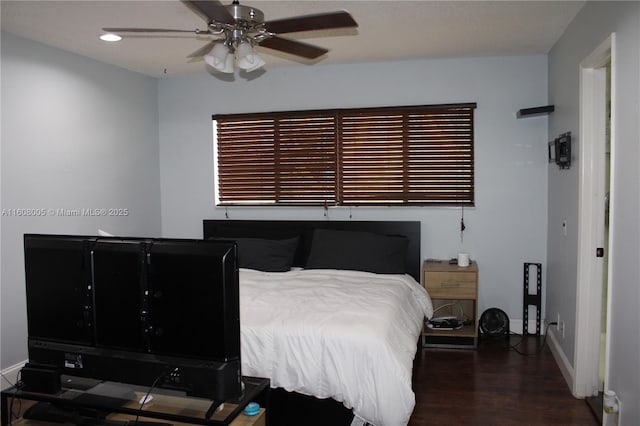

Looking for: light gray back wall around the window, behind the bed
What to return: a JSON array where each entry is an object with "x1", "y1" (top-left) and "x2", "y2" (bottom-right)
[{"x1": 159, "y1": 55, "x2": 547, "y2": 330}]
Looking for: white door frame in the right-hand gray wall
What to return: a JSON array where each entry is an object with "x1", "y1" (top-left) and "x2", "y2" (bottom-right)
[{"x1": 572, "y1": 33, "x2": 615, "y2": 398}]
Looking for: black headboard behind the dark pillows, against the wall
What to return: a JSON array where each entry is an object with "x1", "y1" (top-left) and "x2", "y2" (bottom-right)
[{"x1": 203, "y1": 219, "x2": 421, "y2": 282}]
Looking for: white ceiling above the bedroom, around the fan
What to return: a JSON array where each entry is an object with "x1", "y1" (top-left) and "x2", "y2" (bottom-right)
[{"x1": 0, "y1": 0, "x2": 584, "y2": 77}]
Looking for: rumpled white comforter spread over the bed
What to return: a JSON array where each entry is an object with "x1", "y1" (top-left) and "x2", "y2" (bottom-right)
[{"x1": 240, "y1": 269, "x2": 433, "y2": 426}]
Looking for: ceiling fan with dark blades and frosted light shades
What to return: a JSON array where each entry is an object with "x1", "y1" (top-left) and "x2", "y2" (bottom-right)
[{"x1": 103, "y1": 0, "x2": 358, "y2": 73}]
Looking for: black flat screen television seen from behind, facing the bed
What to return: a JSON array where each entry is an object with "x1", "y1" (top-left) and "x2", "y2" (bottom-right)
[{"x1": 24, "y1": 234, "x2": 242, "y2": 401}]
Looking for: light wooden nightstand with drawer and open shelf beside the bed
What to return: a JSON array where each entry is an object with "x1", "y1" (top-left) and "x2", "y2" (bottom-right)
[{"x1": 422, "y1": 259, "x2": 478, "y2": 348}]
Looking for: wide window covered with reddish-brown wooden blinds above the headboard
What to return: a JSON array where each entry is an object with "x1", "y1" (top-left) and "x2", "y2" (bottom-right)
[{"x1": 213, "y1": 104, "x2": 476, "y2": 206}]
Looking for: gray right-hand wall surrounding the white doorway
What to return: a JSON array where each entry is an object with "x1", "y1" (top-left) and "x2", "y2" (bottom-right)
[{"x1": 547, "y1": 2, "x2": 640, "y2": 425}]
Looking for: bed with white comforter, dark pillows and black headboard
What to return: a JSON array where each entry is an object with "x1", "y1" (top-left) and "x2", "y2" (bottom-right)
[{"x1": 204, "y1": 220, "x2": 432, "y2": 426}]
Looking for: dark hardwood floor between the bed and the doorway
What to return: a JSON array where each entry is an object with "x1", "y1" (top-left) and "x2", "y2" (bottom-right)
[{"x1": 409, "y1": 336, "x2": 598, "y2": 426}]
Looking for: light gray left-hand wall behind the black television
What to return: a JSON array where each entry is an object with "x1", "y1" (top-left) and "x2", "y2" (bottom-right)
[{"x1": 1, "y1": 33, "x2": 161, "y2": 370}]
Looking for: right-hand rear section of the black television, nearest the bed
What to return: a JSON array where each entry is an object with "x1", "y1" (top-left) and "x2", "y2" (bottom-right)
[{"x1": 148, "y1": 241, "x2": 240, "y2": 361}]
